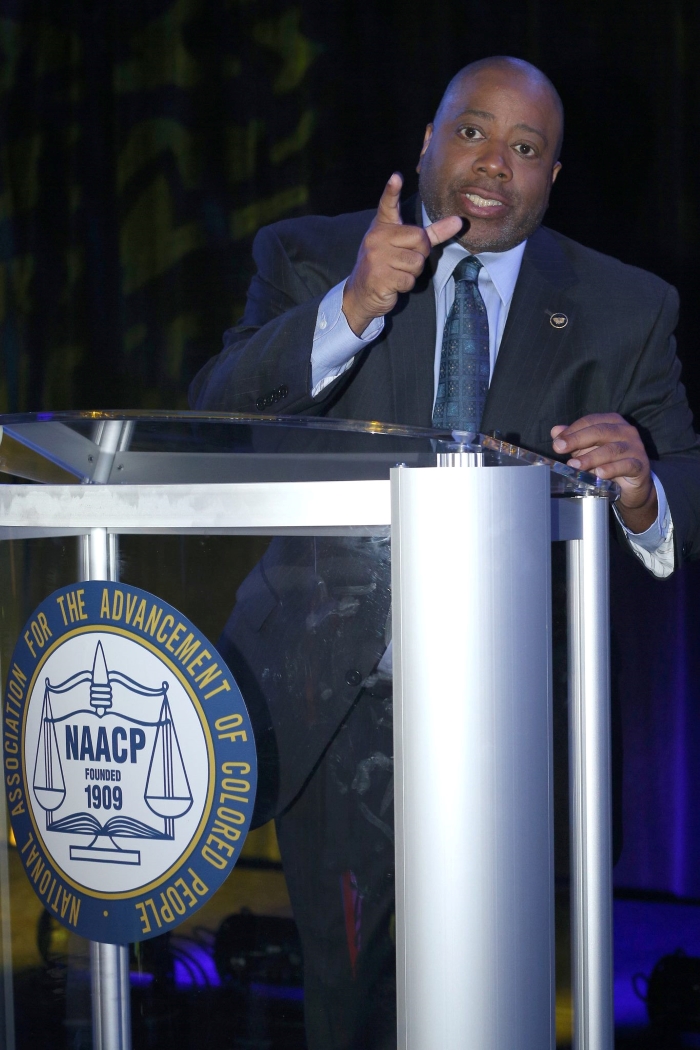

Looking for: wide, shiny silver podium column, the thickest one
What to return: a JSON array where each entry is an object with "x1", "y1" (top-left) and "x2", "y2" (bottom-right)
[{"x1": 391, "y1": 466, "x2": 554, "y2": 1050}]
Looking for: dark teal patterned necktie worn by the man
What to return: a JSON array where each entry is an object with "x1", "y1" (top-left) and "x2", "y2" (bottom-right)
[{"x1": 432, "y1": 255, "x2": 490, "y2": 434}]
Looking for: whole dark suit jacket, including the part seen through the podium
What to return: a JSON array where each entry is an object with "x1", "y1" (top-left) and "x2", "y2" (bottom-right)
[{"x1": 191, "y1": 201, "x2": 700, "y2": 819}]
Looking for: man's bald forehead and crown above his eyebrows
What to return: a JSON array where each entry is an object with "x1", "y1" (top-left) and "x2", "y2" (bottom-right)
[{"x1": 437, "y1": 66, "x2": 560, "y2": 141}]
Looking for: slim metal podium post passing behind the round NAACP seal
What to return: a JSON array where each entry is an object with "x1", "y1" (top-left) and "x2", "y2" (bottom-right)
[{"x1": 80, "y1": 422, "x2": 131, "y2": 1050}]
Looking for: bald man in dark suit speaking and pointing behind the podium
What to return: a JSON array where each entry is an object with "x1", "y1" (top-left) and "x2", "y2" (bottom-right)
[{"x1": 192, "y1": 58, "x2": 700, "y2": 1050}]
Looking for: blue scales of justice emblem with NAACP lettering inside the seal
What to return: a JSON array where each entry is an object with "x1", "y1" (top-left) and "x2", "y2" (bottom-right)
[{"x1": 32, "y1": 641, "x2": 193, "y2": 865}]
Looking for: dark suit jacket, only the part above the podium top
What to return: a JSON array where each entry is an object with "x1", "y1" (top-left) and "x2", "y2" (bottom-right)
[{"x1": 190, "y1": 192, "x2": 700, "y2": 560}]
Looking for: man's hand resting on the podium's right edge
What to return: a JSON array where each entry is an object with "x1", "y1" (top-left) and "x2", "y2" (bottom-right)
[{"x1": 550, "y1": 412, "x2": 658, "y2": 533}]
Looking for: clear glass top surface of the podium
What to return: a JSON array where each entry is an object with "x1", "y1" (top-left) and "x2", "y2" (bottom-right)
[{"x1": 0, "y1": 411, "x2": 619, "y2": 500}]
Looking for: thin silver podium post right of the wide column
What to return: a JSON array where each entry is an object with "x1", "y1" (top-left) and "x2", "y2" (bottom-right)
[{"x1": 567, "y1": 496, "x2": 614, "y2": 1050}]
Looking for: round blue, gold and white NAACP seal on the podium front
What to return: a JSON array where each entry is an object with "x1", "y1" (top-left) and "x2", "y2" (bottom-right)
[{"x1": 3, "y1": 581, "x2": 256, "y2": 944}]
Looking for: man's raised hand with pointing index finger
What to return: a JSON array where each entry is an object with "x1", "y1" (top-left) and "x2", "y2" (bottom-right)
[{"x1": 343, "y1": 171, "x2": 462, "y2": 335}]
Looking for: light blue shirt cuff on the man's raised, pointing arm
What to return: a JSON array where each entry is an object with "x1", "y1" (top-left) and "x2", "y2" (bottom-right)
[{"x1": 311, "y1": 278, "x2": 384, "y2": 397}]
